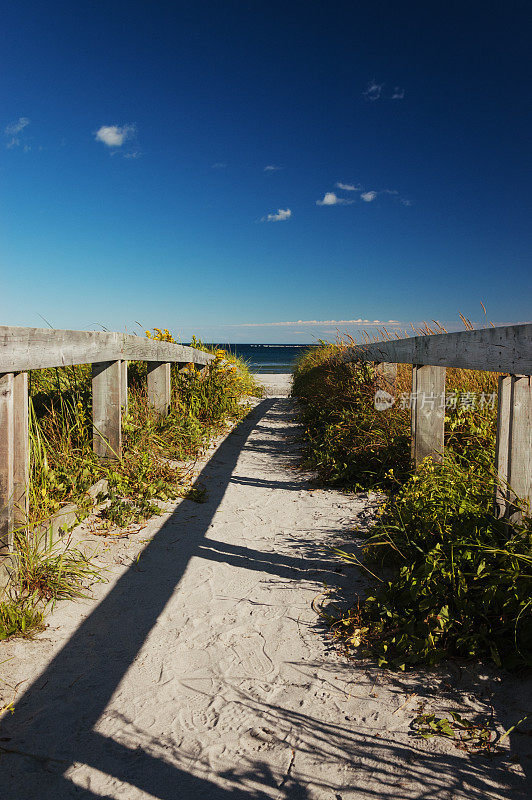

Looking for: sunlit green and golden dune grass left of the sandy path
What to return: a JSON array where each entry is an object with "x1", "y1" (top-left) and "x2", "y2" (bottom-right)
[{"x1": 0, "y1": 329, "x2": 260, "y2": 639}]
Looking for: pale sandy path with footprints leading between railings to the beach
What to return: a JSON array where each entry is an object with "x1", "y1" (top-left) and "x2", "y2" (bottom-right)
[{"x1": 0, "y1": 376, "x2": 527, "y2": 800}]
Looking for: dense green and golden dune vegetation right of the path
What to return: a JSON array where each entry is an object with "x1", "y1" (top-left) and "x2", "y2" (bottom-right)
[{"x1": 293, "y1": 330, "x2": 532, "y2": 669}]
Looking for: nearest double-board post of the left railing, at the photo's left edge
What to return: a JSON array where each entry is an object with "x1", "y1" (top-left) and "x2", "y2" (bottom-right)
[{"x1": 0, "y1": 372, "x2": 29, "y2": 552}]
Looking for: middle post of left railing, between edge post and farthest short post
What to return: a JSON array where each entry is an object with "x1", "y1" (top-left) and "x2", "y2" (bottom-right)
[{"x1": 92, "y1": 361, "x2": 122, "y2": 459}]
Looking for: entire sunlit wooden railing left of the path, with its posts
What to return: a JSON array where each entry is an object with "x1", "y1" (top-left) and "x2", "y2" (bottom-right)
[{"x1": 0, "y1": 326, "x2": 214, "y2": 551}]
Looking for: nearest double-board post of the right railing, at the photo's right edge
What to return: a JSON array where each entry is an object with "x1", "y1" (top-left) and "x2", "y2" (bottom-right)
[{"x1": 495, "y1": 375, "x2": 532, "y2": 522}]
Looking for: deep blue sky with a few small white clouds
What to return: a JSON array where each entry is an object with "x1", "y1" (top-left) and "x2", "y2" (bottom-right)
[{"x1": 0, "y1": 0, "x2": 532, "y2": 342}]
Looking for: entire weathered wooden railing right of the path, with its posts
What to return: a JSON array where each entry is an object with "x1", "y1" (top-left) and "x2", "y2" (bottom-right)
[{"x1": 340, "y1": 324, "x2": 532, "y2": 520}]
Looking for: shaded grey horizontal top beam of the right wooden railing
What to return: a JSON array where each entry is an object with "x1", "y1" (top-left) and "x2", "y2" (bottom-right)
[{"x1": 338, "y1": 323, "x2": 532, "y2": 375}]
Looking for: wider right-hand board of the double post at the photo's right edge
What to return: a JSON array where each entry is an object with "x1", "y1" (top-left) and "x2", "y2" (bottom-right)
[{"x1": 507, "y1": 375, "x2": 532, "y2": 522}]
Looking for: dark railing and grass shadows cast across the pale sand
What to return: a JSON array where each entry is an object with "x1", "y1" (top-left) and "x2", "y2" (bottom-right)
[{"x1": 0, "y1": 399, "x2": 526, "y2": 800}]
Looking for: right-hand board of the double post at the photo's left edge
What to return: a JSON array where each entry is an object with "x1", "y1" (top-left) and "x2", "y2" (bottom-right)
[{"x1": 13, "y1": 372, "x2": 30, "y2": 528}]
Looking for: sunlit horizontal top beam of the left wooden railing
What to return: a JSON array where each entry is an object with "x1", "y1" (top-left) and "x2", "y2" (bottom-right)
[{"x1": 0, "y1": 326, "x2": 214, "y2": 372}]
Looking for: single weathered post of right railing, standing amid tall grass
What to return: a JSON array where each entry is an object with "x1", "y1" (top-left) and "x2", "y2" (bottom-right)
[{"x1": 410, "y1": 364, "x2": 445, "y2": 467}]
